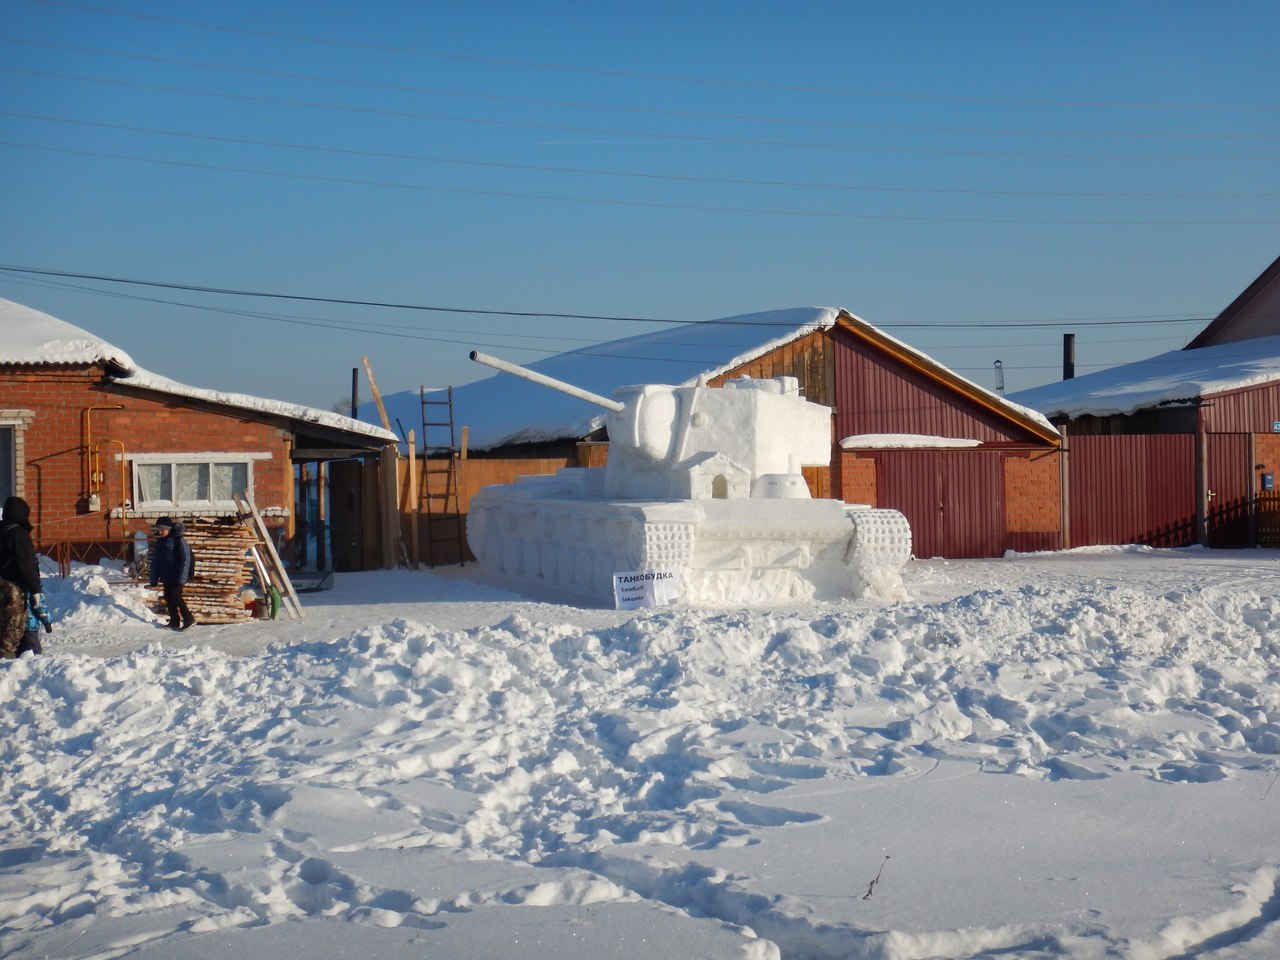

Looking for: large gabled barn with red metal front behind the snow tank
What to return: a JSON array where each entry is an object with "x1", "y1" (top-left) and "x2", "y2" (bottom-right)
[{"x1": 361, "y1": 307, "x2": 1061, "y2": 557}]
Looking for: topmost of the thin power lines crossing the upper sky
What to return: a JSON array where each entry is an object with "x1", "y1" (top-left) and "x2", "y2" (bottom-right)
[{"x1": 29, "y1": 0, "x2": 1280, "y2": 111}]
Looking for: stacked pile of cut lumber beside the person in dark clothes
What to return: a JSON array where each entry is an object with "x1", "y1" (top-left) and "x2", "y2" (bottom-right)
[{"x1": 152, "y1": 518, "x2": 259, "y2": 623}]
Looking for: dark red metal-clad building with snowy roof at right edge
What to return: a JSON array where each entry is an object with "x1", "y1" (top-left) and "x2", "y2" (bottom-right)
[{"x1": 1012, "y1": 253, "x2": 1280, "y2": 548}]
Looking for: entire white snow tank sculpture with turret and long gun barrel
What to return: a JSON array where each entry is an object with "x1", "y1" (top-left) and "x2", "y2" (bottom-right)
[{"x1": 467, "y1": 352, "x2": 911, "y2": 604}]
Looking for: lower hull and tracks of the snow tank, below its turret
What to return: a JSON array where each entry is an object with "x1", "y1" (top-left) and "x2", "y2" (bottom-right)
[{"x1": 467, "y1": 470, "x2": 910, "y2": 605}]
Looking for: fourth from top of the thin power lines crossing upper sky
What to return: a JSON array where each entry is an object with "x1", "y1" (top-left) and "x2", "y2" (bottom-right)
[{"x1": 12, "y1": 110, "x2": 1280, "y2": 200}]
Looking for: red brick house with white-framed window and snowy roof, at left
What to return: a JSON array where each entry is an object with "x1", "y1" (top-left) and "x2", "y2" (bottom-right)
[{"x1": 0, "y1": 300, "x2": 398, "y2": 568}]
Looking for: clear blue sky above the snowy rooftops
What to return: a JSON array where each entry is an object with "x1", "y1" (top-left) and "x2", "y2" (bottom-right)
[{"x1": 0, "y1": 0, "x2": 1280, "y2": 407}]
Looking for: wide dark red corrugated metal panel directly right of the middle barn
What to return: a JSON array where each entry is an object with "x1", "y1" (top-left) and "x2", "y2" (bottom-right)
[{"x1": 1068, "y1": 434, "x2": 1197, "y2": 547}]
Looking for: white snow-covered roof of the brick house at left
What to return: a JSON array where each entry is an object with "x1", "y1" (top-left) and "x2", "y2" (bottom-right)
[{"x1": 0, "y1": 300, "x2": 397, "y2": 440}]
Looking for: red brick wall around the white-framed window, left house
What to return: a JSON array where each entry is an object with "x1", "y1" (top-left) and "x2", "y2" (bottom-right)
[{"x1": 0, "y1": 367, "x2": 293, "y2": 548}]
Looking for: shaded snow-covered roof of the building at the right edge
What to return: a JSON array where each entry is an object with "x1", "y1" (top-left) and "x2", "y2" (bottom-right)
[{"x1": 1011, "y1": 337, "x2": 1280, "y2": 417}]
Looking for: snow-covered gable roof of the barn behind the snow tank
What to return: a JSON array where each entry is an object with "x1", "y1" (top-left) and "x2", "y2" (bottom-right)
[{"x1": 358, "y1": 307, "x2": 1053, "y2": 449}]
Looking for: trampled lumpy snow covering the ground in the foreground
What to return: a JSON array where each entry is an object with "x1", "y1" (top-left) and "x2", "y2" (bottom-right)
[{"x1": 0, "y1": 549, "x2": 1280, "y2": 960}]
